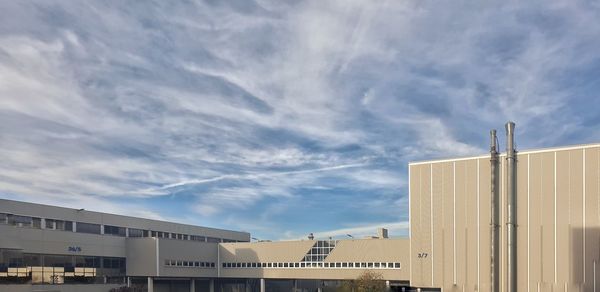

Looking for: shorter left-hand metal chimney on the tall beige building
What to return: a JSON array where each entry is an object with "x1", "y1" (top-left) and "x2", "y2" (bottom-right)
[{"x1": 490, "y1": 129, "x2": 500, "y2": 292}]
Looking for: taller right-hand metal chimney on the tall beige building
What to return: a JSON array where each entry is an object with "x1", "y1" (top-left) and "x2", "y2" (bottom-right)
[{"x1": 506, "y1": 122, "x2": 517, "y2": 292}]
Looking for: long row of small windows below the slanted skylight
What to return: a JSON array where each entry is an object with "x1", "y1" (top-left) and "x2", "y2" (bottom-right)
[{"x1": 223, "y1": 262, "x2": 401, "y2": 269}]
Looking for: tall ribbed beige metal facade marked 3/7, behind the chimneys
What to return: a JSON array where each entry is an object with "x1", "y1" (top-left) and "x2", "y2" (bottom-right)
[{"x1": 409, "y1": 145, "x2": 600, "y2": 291}]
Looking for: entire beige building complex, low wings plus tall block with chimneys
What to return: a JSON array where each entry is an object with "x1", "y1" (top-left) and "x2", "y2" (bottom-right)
[{"x1": 0, "y1": 123, "x2": 600, "y2": 292}]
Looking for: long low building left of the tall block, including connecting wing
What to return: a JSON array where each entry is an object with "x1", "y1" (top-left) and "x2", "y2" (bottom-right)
[{"x1": 0, "y1": 199, "x2": 410, "y2": 292}]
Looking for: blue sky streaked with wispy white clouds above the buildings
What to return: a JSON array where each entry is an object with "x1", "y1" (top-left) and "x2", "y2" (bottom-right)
[{"x1": 0, "y1": 0, "x2": 600, "y2": 240}]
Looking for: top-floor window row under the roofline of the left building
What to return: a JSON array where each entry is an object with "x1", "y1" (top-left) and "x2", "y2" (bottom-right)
[{"x1": 0, "y1": 213, "x2": 244, "y2": 243}]
